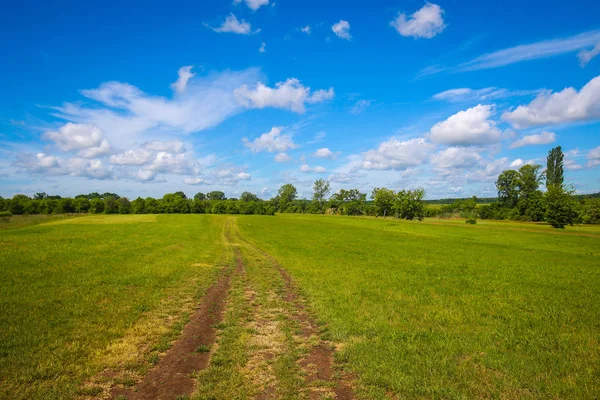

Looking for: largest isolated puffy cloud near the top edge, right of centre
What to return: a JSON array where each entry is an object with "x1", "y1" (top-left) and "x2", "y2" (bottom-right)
[{"x1": 390, "y1": 3, "x2": 446, "y2": 39}]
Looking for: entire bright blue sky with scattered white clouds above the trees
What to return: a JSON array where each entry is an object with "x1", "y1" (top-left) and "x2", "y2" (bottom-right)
[{"x1": 0, "y1": 0, "x2": 600, "y2": 198}]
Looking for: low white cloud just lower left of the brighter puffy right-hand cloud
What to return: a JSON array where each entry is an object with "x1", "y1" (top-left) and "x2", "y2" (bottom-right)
[{"x1": 357, "y1": 138, "x2": 433, "y2": 170}]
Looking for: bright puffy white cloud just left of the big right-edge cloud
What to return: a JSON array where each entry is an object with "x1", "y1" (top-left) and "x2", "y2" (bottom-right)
[{"x1": 429, "y1": 104, "x2": 502, "y2": 146}]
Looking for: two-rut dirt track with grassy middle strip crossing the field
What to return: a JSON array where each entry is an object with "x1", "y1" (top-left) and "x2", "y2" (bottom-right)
[{"x1": 98, "y1": 218, "x2": 354, "y2": 400}]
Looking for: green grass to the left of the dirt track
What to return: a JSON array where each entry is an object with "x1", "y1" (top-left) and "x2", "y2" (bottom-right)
[{"x1": 0, "y1": 215, "x2": 224, "y2": 399}]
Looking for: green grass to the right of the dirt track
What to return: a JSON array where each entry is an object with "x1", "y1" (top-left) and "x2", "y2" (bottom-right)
[{"x1": 238, "y1": 215, "x2": 600, "y2": 399}]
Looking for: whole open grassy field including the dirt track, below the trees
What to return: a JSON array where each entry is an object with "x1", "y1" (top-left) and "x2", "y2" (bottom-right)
[{"x1": 0, "y1": 215, "x2": 600, "y2": 399}]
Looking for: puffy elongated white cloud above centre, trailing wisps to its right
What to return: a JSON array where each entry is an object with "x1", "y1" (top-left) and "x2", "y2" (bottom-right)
[{"x1": 235, "y1": 78, "x2": 335, "y2": 113}]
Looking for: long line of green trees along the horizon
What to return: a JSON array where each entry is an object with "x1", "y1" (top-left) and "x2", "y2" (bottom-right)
[{"x1": 0, "y1": 146, "x2": 600, "y2": 228}]
